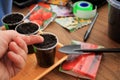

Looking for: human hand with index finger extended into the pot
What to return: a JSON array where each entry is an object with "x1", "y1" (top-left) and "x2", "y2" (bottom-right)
[{"x1": 0, "y1": 30, "x2": 43, "y2": 80}]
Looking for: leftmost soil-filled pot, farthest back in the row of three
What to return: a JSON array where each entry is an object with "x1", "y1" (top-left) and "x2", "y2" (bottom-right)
[{"x1": 2, "y1": 12, "x2": 24, "y2": 30}]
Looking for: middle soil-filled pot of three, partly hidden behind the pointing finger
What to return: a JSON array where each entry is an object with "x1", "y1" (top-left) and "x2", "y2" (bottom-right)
[{"x1": 15, "y1": 22, "x2": 40, "y2": 54}]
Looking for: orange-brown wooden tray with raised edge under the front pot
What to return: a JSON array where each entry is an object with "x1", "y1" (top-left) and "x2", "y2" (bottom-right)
[{"x1": 11, "y1": 43, "x2": 68, "y2": 80}]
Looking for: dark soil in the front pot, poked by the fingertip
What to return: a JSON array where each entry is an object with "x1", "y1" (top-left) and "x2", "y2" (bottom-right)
[{"x1": 35, "y1": 34, "x2": 57, "y2": 48}]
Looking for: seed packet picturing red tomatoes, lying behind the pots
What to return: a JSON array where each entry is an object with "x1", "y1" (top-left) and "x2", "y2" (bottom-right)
[{"x1": 27, "y1": 5, "x2": 57, "y2": 30}]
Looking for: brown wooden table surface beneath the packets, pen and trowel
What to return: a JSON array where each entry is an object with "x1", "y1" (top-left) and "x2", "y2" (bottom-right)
[{"x1": 13, "y1": 4, "x2": 120, "y2": 80}]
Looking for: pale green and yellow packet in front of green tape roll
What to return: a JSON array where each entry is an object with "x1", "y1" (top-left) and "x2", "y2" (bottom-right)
[{"x1": 55, "y1": 17, "x2": 91, "y2": 32}]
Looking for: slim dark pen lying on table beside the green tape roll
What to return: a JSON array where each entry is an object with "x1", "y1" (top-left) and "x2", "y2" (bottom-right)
[{"x1": 84, "y1": 13, "x2": 98, "y2": 42}]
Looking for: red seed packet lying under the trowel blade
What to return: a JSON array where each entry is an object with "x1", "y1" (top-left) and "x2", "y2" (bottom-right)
[{"x1": 59, "y1": 42, "x2": 102, "y2": 80}]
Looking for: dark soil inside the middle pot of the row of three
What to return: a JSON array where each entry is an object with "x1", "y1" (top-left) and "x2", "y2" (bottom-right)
[{"x1": 17, "y1": 23, "x2": 38, "y2": 34}]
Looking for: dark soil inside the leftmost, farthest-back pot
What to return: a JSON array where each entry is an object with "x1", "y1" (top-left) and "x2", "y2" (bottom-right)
[{"x1": 3, "y1": 14, "x2": 23, "y2": 24}]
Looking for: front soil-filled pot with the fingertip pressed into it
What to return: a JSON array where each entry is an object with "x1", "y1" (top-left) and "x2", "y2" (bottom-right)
[{"x1": 33, "y1": 32, "x2": 58, "y2": 68}]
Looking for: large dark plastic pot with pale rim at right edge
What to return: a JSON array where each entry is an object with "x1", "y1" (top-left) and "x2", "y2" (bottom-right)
[{"x1": 107, "y1": 0, "x2": 120, "y2": 43}]
